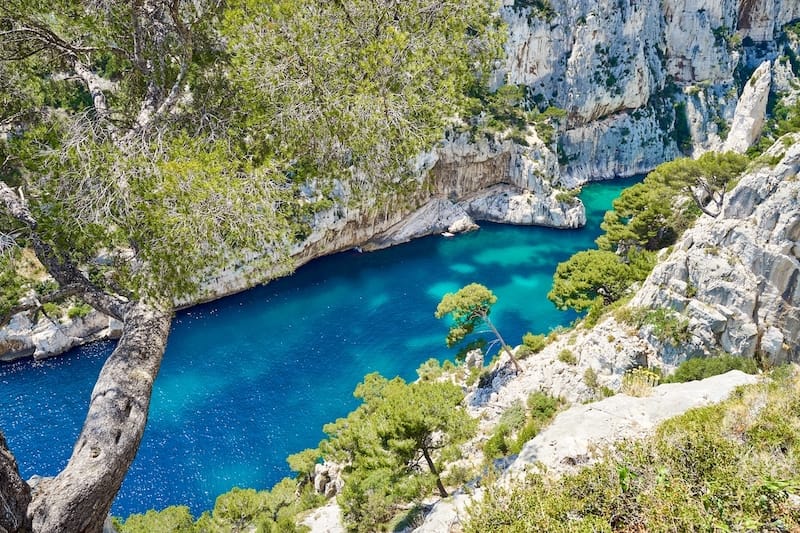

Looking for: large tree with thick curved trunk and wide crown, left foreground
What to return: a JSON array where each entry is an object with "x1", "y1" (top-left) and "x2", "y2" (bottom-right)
[{"x1": 0, "y1": 0, "x2": 500, "y2": 532}]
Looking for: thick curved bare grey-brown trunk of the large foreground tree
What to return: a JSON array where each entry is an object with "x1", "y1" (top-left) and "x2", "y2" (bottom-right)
[{"x1": 28, "y1": 302, "x2": 171, "y2": 533}]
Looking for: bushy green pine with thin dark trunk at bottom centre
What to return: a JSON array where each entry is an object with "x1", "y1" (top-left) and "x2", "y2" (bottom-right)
[{"x1": 290, "y1": 374, "x2": 475, "y2": 532}]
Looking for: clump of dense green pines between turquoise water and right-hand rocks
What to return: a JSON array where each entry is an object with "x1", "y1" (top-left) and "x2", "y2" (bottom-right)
[{"x1": 547, "y1": 152, "x2": 748, "y2": 316}]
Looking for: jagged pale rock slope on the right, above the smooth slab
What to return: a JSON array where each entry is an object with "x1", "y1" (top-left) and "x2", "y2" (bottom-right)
[{"x1": 456, "y1": 134, "x2": 800, "y2": 424}]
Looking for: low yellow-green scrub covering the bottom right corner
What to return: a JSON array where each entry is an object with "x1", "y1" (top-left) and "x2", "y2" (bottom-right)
[{"x1": 465, "y1": 367, "x2": 800, "y2": 533}]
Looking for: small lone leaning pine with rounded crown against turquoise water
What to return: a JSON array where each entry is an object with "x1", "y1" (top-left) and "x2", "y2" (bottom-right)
[{"x1": 434, "y1": 283, "x2": 522, "y2": 373}]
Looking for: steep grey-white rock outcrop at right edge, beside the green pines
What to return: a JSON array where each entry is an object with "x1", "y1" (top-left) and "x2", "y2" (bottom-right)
[{"x1": 631, "y1": 135, "x2": 800, "y2": 365}]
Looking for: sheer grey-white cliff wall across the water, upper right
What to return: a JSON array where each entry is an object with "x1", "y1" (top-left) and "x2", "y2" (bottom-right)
[{"x1": 499, "y1": 0, "x2": 800, "y2": 185}]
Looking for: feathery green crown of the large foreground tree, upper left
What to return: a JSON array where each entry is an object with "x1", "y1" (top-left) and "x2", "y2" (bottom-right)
[{"x1": 0, "y1": 0, "x2": 502, "y2": 307}]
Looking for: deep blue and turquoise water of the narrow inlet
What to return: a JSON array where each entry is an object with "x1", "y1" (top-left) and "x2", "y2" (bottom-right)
[{"x1": 0, "y1": 176, "x2": 635, "y2": 515}]
